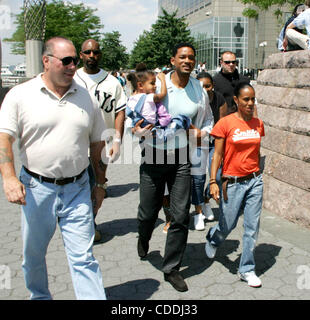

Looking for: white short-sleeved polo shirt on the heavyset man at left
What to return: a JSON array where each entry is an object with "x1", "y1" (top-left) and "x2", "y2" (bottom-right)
[{"x1": 0, "y1": 74, "x2": 105, "y2": 178}]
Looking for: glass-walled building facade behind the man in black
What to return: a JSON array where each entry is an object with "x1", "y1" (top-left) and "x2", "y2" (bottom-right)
[{"x1": 158, "y1": 0, "x2": 249, "y2": 73}]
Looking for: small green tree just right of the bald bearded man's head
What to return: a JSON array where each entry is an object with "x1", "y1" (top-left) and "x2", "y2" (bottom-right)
[{"x1": 100, "y1": 31, "x2": 129, "y2": 70}]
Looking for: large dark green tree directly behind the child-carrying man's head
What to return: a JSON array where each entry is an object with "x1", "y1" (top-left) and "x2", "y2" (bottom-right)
[{"x1": 130, "y1": 9, "x2": 194, "y2": 69}]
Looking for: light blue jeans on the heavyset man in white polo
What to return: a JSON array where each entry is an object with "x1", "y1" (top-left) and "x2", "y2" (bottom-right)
[{"x1": 20, "y1": 168, "x2": 106, "y2": 300}]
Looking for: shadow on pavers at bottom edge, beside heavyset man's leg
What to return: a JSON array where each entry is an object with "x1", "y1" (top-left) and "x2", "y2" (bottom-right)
[{"x1": 105, "y1": 279, "x2": 160, "y2": 300}]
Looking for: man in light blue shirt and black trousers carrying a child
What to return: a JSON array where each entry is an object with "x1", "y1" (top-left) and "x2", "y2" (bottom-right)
[{"x1": 132, "y1": 43, "x2": 213, "y2": 291}]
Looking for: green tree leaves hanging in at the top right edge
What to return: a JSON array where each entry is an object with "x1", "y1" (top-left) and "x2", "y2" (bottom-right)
[{"x1": 238, "y1": 0, "x2": 303, "y2": 18}]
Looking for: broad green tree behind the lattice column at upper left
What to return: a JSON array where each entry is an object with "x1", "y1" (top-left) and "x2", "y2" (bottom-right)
[{"x1": 3, "y1": 0, "x2": 103, "y2": 54}]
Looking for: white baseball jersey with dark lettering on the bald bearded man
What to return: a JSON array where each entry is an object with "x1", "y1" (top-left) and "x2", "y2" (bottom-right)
[{"x1": 74, "y1": 68, "x2": 127, "y2": 129}]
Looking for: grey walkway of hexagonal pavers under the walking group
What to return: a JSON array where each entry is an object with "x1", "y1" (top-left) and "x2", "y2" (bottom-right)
[{"x1": 0, "y1": 148, "x2": 310, "y2": 300}]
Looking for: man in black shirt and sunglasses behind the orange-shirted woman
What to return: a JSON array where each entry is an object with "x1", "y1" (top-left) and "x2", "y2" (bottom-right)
[{"x1": 213, "y1": 51, "x2": 250, "y2": 114}]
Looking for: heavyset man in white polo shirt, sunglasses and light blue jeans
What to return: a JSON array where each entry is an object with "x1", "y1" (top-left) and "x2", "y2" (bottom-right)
[{"x1": 0, "y1": 37, "x2": 106, "y2": 299}]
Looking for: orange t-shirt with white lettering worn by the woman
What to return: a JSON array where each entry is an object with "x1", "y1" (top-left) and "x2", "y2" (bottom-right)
[{"x1": 211, "y1": 114, "x2": 265, "y2": 177}]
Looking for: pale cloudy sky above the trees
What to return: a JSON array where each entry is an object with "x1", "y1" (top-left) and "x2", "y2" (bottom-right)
[{"x1": 0, "y1": 0, "x2": 158, "y2": 65}]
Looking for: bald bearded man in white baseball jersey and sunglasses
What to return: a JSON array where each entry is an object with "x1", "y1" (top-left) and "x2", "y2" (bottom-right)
[{"x1": 74, "y1": 39, "x2": 127, "y2": 241}]
